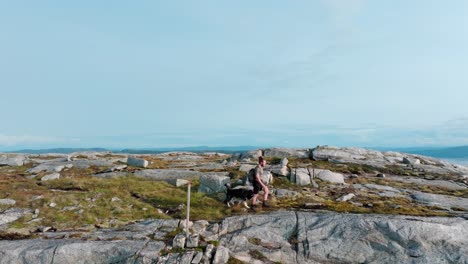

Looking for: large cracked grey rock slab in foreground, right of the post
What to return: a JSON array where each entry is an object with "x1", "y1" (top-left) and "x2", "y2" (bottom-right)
[{"x1": 220, "y1": 212, "x2": 468, "y2": 263}]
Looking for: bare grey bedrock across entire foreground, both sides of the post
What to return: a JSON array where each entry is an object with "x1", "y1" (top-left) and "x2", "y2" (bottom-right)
[{"x1": 0, "y1": 211, "x2": 468, "y2": 264}]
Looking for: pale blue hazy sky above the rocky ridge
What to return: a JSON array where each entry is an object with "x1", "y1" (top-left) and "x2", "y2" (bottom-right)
[{"x1": 0, "y1": 0, "x2": 468, "y2": 151}]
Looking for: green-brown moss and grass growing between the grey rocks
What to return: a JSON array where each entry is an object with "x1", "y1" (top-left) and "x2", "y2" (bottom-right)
[{"x1": 0, "y1": 155, "x2": 462, "y2": 233}]
